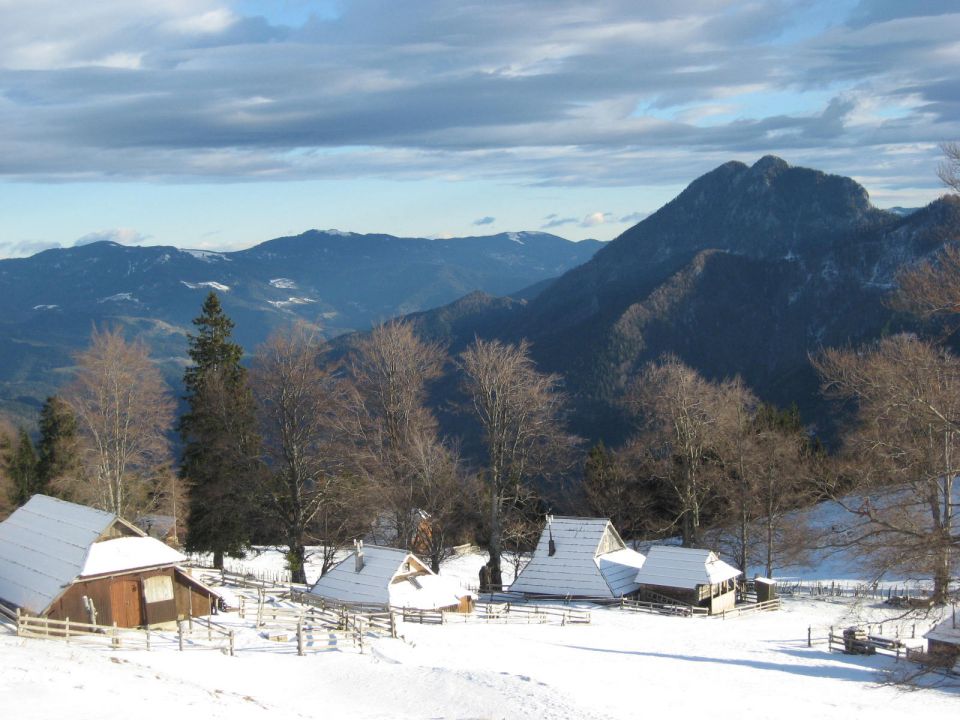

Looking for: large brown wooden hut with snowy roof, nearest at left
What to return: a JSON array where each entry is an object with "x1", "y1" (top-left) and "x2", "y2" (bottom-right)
[{"x1": 0, "y1": 495, "x2": 219, "y2": 627}]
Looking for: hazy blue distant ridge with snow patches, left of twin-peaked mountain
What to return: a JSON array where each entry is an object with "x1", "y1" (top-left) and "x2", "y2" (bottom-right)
[{"x1": 0, "y1": 230, "x2": 603, "y2": 422}]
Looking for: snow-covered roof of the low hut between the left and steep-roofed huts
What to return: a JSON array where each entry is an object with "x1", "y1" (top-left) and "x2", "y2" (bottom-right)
[{"x1": 310, "y1": 545, "x2": 465, "y2": 609}]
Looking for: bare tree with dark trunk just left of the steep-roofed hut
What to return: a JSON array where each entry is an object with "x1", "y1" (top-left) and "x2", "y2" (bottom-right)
[{"x1": 460, "y1": 338, "x2": 570, "y2": 589}]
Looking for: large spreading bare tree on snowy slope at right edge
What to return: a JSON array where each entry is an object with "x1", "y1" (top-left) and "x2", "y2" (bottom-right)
[{"x1": 815, "y1": 335, "x2": 960, "y2": 602}]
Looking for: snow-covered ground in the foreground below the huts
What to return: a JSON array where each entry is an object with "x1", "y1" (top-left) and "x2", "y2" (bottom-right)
[{"x1": 0, "y1": 553, "x2": 960, "y2": 720}]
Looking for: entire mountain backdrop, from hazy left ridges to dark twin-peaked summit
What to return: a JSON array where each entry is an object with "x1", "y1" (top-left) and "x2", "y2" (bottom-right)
[{"x1": 0, "y1": 156, "x2": 960, "y2": 443}]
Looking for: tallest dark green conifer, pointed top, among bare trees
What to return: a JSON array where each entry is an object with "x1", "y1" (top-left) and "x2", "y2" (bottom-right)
[{"x1": 180, "y1": 292, "x2": 260, "y2": 568}]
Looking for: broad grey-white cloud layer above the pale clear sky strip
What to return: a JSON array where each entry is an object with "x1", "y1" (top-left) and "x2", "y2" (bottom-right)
[{"x1": 0, "y1": 0, "x2": 948, "y2": 202}]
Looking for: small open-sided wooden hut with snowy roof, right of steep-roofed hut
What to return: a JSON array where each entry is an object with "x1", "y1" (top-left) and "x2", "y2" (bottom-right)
[{"x1": 635, "y1": 545, "x2": 741, "y2": 614}]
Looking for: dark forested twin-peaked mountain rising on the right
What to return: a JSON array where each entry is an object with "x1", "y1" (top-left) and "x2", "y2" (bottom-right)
[{"x1": 392, "y1": 156, "x2": 960, "y2": 442}]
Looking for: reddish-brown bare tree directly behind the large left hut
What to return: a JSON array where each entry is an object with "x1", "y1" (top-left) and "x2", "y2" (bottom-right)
[{"x1": 63, "y1": 330, "x2": 174, "y2": 518}]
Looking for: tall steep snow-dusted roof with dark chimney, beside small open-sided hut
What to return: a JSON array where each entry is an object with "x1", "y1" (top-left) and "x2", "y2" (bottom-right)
[{"x1": 510, "y1": 517, "x2": 644, "y2": 598}]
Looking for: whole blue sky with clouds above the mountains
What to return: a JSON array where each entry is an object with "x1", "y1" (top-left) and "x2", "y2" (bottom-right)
[{"x1": 0, "y1": 0, "x2": 960, "y2": 257}]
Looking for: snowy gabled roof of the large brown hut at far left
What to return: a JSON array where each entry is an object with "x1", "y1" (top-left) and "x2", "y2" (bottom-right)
[{"x1": 0, "y1": 495, "x2": 183, "y2": 614}]
